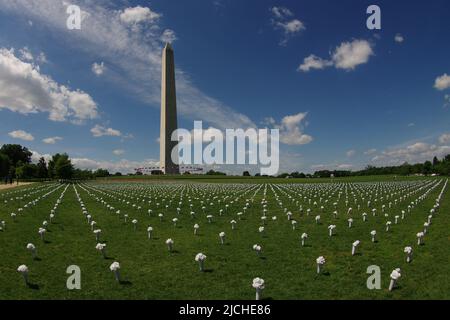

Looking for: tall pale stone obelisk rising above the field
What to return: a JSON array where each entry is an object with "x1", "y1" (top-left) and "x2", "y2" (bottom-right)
[{"x1": 159, "y1": 43, "x2": 180, "y2": 174}]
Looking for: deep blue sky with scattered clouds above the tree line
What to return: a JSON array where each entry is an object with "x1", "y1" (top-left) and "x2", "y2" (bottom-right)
[{"x1": 0, "y1": 0, "x2": 450, "y2": 172}]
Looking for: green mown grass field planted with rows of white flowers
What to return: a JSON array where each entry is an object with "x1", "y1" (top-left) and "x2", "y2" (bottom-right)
[{"x1": 0, "y1": 177, "x2": 450, "y2": 299}]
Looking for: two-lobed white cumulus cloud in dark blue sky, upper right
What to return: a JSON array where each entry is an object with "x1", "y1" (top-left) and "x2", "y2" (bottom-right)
[{"x1": 297, "y1": 39, "x2": 374, "y2": 72}]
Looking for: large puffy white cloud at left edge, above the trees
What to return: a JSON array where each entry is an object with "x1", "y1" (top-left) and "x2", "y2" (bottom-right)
[{"x1": 0, "y1": 48, "x2": 98, "y2": 122}]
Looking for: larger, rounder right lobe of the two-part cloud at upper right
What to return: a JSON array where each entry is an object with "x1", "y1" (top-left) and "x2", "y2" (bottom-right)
[{"x1": 333, "y1": 40, "x2": 373, "y2": 70}]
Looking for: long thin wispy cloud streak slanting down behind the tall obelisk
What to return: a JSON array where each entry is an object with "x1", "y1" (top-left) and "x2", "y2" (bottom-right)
[{"x1": 0, "y1": 0, "x2": 255, "y2": 129}]
